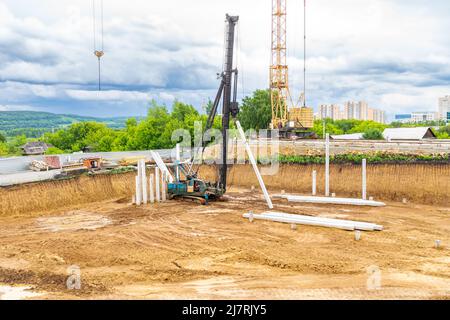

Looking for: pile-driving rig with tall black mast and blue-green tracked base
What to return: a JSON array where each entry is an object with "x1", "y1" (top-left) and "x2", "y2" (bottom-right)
[{"x1": 167, "y1": 14, "x2": 239, "y2": 204}]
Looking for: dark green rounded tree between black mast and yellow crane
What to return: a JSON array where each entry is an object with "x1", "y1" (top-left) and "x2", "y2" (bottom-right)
[{"x1": 238, "y1": 90, "x2": 272, "y2": 130}]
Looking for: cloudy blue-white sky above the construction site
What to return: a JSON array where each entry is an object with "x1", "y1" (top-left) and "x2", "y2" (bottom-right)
[{"x1": 0, "y1": 0, "x2": 450, "y2": 120}]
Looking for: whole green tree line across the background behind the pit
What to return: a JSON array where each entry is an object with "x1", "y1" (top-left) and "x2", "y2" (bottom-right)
[{"x1": 0, "y1": 90, "x2": 450, "y2": 156}]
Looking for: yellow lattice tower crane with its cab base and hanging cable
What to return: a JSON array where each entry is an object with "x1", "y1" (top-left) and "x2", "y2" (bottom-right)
[{"x1": 270, "y1": 0, "x2": 314, "y2": 138}]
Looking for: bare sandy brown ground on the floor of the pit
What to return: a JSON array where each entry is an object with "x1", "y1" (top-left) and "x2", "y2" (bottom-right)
[{"x1": 0, "y1": 190, "x2": 450, "y2": 299}]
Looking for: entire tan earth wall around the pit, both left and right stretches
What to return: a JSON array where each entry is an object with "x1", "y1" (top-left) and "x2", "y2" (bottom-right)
[{"x1": 0, "y1": 164, "x2": 450, "y2": 216}]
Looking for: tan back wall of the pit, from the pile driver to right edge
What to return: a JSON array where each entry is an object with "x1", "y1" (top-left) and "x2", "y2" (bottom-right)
[{"x1": 222, "y1": 163, "x2": 450, "y2": 206}]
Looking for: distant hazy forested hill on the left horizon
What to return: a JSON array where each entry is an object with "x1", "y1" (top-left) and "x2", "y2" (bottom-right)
[{"x1": 0, "y1": 111, "x2": 139, "y2": 138}]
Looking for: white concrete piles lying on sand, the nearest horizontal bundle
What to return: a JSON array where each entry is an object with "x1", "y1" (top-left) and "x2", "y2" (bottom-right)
[{"x1": 243, "y1": 211, "x2": 383, "y2": 231}]
